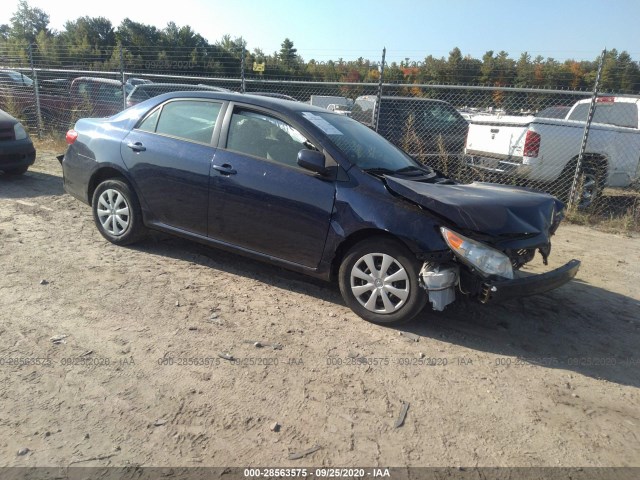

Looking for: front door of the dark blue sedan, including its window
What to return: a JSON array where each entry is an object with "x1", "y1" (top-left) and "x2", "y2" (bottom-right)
[{"x1": 209, "y1": 105, "x2": 335, "y2": 267}]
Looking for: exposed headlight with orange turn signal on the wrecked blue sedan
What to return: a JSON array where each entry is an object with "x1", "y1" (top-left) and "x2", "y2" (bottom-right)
[{"x1": 440, "y1": 227, "x2": 513, "y2": 279}]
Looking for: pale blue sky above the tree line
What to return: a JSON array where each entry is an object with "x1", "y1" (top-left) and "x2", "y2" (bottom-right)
[{"x1": 0, "y1": 0, "x2": 640, "y2": 62}]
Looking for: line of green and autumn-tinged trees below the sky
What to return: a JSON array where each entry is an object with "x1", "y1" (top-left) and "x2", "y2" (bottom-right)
[{"x1": 0, "y1": 0, "x2": 640, "y2": 94}]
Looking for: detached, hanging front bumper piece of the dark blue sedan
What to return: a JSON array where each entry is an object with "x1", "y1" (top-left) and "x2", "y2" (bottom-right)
[{"x1": 479, "y1": 260, "x2": 580, "y2": 303}]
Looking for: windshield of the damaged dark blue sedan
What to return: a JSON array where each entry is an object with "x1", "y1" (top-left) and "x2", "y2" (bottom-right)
[{"x1": 302, "y1": 112, "x2": 425, "y2": 172}]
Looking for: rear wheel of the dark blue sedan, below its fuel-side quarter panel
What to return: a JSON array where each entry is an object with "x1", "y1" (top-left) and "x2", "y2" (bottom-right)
[{"x1": 91, "y1": 180, "x2": 145, "y2": 245}]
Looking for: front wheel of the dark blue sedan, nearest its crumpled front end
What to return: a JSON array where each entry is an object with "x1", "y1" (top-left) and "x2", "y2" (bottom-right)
[{"x1": 338, "y1": 237, "x2": 428, "y2": 325}]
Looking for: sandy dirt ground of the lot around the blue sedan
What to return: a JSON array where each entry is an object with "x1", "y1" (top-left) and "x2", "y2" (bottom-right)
[{"x1": 0, "y1": 148, "x2": 640, "y2": 466}]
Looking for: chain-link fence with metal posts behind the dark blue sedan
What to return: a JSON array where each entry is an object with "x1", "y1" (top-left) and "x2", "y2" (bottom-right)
[{"x1": 0, "y1": 42, "x2": 640, "y2": 229}]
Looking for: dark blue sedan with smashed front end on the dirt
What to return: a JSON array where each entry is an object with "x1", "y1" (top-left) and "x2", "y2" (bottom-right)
[{"x1": 61, "y1": 92, "x2": 580, "y2": 323}]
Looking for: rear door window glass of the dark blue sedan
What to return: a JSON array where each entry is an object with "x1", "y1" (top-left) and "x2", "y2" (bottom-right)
[{"x1": 138, "y1": 100, "x2": 222, "y2": 143}]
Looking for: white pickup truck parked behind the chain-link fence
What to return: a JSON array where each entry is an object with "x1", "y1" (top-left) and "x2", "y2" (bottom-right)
[{"x1": 465, "y1": 96, "x2": 640, "y2": 207}]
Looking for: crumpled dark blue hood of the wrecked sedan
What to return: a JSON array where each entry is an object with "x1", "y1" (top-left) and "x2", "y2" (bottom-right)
[{"x1": 385, "y1": 176, "x2": 564, "y2": 247}]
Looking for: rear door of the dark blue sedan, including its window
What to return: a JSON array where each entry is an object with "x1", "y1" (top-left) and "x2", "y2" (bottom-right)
[{"x1": 120, "y1": 99, "x2": 223, "y2": 236}]
